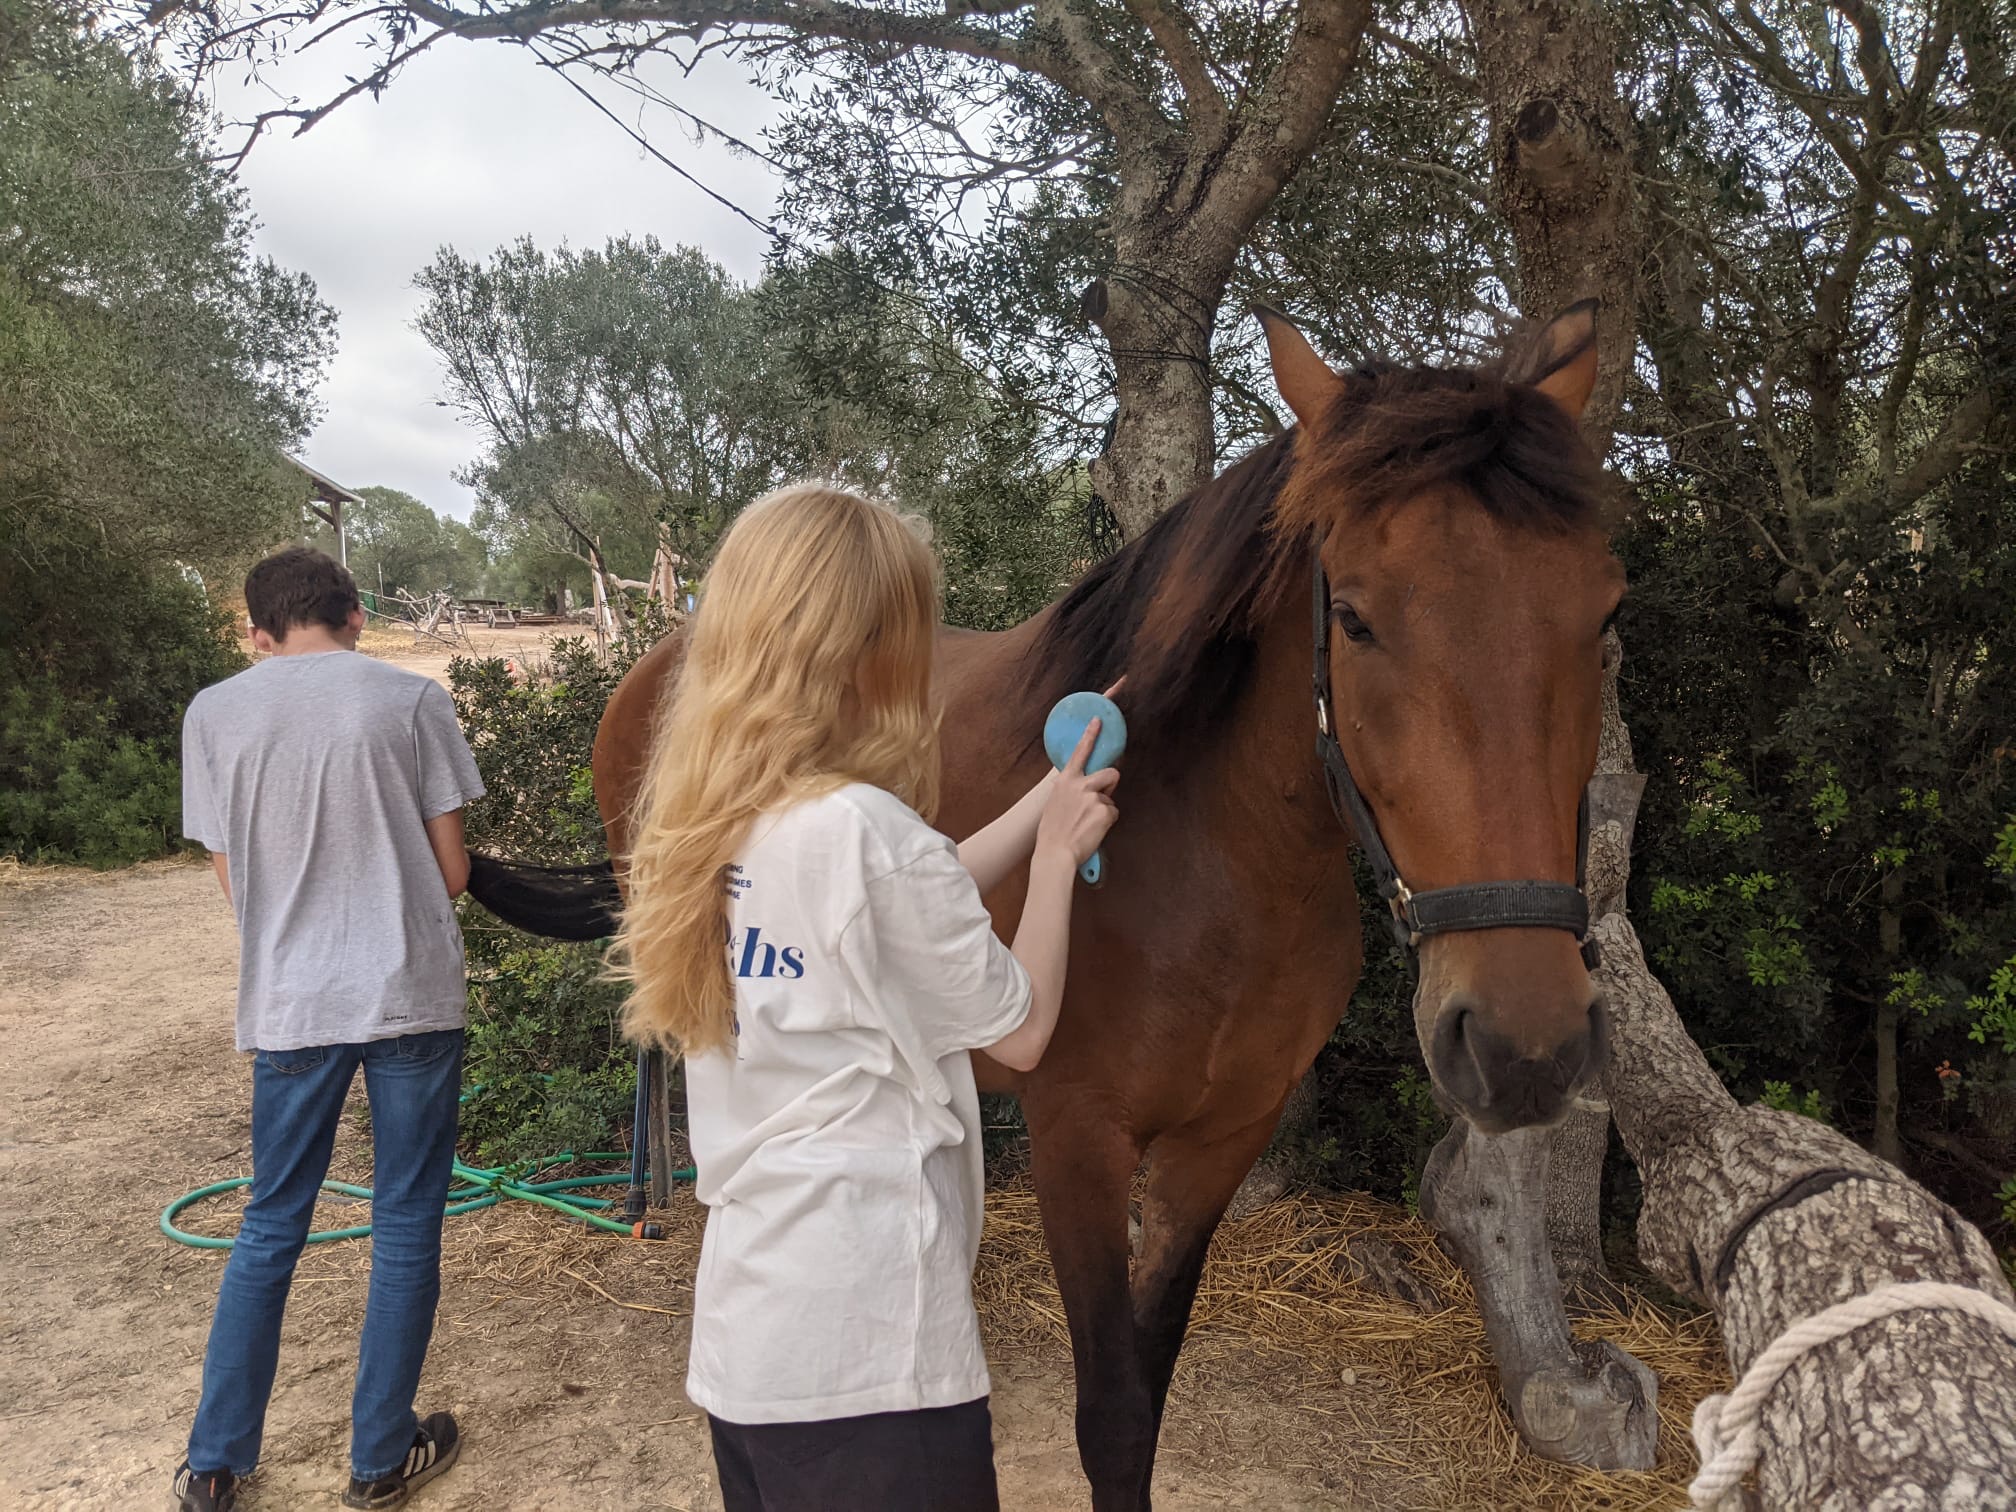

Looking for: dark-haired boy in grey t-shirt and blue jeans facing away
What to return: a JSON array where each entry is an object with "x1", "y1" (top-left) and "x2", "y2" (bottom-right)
[{"x1": 173, "y1": 546, "x2": 484, "y2": 1512}]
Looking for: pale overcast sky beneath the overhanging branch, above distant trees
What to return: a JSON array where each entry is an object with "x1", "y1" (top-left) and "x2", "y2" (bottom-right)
[{"x1": 218, "y1": 42, "x2": 774, "y2": 518}]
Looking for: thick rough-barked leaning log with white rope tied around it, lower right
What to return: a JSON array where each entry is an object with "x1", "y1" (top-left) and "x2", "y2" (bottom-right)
[{"x1": 1595, "y1": 913, "x2": 2016, "y2": 1512}]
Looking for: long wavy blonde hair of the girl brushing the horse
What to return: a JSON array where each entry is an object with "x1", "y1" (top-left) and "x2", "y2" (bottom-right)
[{"x1": 611, "y1": 484, "x2": 939, "y2": 1052}]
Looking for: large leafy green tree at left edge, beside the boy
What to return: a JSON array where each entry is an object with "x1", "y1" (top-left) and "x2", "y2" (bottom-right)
[{"x1": 0, "y1": 0, "x2": 335, "y2": 865}]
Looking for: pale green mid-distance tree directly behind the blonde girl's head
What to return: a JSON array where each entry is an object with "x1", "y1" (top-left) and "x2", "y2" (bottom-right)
[{"x1": 419, "y1": 238, "x2": 1095, "y2": 625}]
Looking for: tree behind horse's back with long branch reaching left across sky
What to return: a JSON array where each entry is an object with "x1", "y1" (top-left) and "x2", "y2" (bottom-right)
[{"x1": 169, "y1": 0, "x2": 1369, "y2": 532}]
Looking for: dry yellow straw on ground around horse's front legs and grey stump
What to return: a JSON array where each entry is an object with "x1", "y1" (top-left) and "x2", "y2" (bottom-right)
[{"x1": 974, "y1": 1185, "x2": 1728, "y2": 1512}]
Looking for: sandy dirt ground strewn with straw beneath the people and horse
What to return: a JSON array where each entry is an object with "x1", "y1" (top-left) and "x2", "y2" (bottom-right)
[{"x1": 0, "y1": 861, "x2": 1714, "y2": 1512}]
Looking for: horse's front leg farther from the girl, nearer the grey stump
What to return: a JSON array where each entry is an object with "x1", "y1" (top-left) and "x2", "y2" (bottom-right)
[{"x1": 1133, "y1": 1107, "x2": 1280, "y2": 1443}]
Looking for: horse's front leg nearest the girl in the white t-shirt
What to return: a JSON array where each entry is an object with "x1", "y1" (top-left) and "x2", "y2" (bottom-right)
[{"x1": 1024, "y1": 1097, "x2": 1155, "y2": 1512}]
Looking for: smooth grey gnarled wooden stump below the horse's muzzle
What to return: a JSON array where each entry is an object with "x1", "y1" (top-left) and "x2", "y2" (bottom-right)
[{"x1": 1421, "y1": 1119, "x2": 1659, "y2": 1470}]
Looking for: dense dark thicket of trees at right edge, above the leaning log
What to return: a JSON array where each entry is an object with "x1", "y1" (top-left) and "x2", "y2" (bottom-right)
[{"x1": 1627, "y1": 0, "x2": 2016, "y2": 1185}]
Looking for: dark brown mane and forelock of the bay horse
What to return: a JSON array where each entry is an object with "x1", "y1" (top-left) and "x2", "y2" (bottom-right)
[{"x1": 1024, "y1": 365, "x2": 1613, "y2": 766}]
